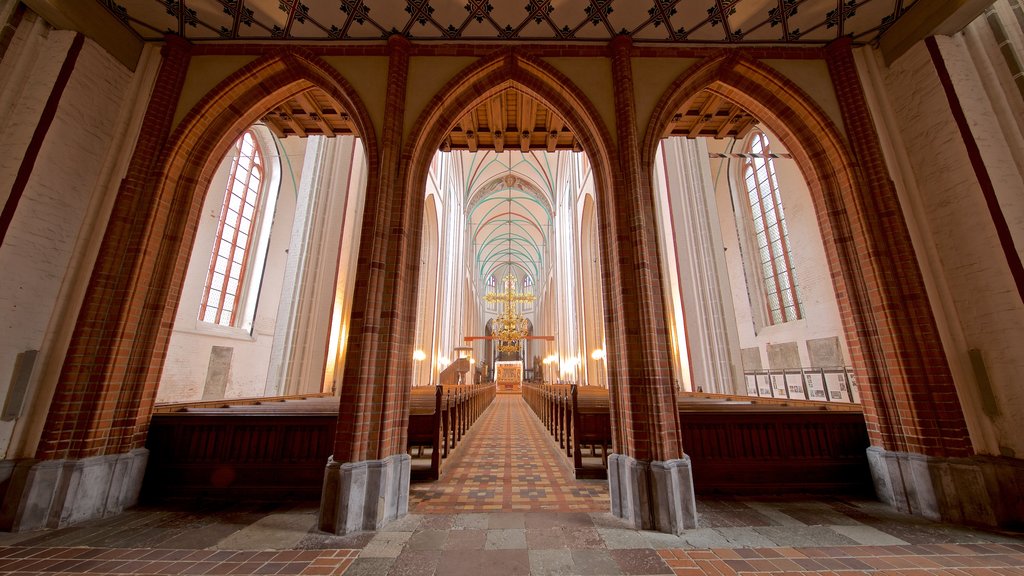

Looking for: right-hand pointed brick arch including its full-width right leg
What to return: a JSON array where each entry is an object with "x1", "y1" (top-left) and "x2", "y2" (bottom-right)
[{"x1": 641, "y1": 53, "x2": 971, "y2": 457}]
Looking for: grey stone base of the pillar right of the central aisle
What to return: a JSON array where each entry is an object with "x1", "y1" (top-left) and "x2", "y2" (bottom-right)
[{"x1": 608, "y1": 454, "x2": 697, "y2": 534}]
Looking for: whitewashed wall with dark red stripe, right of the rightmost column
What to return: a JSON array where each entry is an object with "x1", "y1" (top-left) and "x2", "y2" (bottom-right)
[{"x1": 858, "y1": 23, "x2": 1024, "y2": 458}]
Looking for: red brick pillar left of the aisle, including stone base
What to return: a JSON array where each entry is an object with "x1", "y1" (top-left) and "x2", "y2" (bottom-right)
[{"x1": 319, "y1": 35, "x2": 415, "y2": 533}]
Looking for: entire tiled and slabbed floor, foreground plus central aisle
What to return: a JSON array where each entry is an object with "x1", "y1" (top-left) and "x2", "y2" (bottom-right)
[{"x1": 0, "y1": 391, "x2": 1024, "y2": 576}]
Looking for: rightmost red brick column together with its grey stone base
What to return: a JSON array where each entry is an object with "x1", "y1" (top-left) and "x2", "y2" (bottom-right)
[{"x1": 825, "y1": 38, "x2": 1011, "y2": 524}]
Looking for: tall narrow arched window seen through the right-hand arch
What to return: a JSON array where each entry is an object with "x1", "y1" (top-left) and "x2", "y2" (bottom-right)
[{"x1": 741, "y1": 131, "x2": 803, "y2": 324}]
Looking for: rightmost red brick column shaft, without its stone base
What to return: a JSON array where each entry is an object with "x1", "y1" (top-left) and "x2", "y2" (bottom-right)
[{"x1": 825, "y1": 38, "x2": 973, "y2": 457}]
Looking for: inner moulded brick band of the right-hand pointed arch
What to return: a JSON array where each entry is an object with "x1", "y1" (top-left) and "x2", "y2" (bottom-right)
[{"x1": 641, "y1": 53, "x2": 894, "y2": 445}]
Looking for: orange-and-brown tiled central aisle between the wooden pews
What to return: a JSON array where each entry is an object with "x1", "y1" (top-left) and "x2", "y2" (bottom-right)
[{"x1": 409, "y1": 395, "x2": 610, "y2": 513}]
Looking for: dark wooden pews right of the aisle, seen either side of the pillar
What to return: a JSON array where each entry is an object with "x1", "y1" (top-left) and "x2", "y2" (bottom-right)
[{"x1": 523, "y1": 384, "x2": 872, "y2": 494}]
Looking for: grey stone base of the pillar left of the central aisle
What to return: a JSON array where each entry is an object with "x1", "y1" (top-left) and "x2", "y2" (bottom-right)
[{"x1": 318, "y1": 454, "x2": 412, "y2": 534}]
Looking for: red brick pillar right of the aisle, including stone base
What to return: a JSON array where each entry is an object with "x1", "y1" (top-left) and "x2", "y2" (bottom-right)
[{"x1": 598, "y1": 35, "x2": 696, "y2": 533}]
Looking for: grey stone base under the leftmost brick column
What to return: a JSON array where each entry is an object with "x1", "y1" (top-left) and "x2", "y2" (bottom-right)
[{"x1": 0, "y1": 448, "x2": 150, "y2": 532}]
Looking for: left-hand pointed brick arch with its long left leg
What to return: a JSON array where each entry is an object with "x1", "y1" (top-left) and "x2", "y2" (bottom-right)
[{"x1": 38, "y1": 48, "x2": 377, "y2": 457}]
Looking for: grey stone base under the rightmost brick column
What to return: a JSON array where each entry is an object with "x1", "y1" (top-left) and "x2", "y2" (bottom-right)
[{"x1": 867, "y1": 446, "x2": 1024, "y2": 526}]
